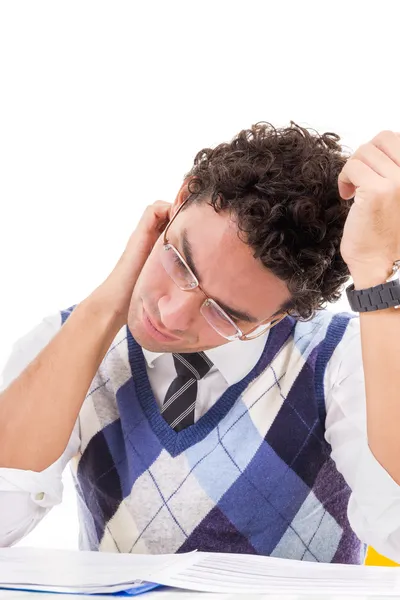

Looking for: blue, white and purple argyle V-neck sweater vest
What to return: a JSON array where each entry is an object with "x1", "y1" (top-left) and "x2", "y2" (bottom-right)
[{"x1": 62, "y1": 307, "x2": 365, "y2": 563}]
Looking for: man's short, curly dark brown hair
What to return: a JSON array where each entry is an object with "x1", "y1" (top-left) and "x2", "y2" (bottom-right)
[{"x1": 185, "y1": 121, "x2": 351, "y2": 320}]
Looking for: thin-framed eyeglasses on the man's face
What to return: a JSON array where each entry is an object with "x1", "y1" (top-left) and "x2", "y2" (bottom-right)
[{"x1": 161, "y1": 196, "x2": 286, "y2": 341}]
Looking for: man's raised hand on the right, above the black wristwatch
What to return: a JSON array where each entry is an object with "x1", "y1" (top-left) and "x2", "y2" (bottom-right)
[{"x1": 339, "y1": 131, "x2": 400, "y2": 288}]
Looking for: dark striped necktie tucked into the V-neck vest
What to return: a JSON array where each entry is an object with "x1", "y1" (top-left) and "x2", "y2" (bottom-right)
[{"x1": 161, "y1": 352, "x2": 213, "y2": 431}]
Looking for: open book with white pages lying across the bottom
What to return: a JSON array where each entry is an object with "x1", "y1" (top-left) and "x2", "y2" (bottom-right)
[{"x1": 0, "y1": 548, "x2": 400, "y2": 596}]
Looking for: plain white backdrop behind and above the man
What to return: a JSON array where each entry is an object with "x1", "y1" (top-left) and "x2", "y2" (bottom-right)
[{"x1": 0, "y1": 0, "x2": 400, "y2": 548}]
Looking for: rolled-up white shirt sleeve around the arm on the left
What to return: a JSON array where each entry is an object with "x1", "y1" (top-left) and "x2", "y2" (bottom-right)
[{"x1": 0, "y1": 314, "x2": 80, "y2": 547}]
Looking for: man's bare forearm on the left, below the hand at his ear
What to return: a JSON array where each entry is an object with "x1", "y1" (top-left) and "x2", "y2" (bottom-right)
[{"x1": 0, "y1": 290, "x2": 121, "y2": 471}]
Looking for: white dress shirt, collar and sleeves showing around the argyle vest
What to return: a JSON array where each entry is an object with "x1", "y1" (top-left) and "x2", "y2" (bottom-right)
[{"x1": 0, "y1": 314, "x2": 400, "y2": 562}]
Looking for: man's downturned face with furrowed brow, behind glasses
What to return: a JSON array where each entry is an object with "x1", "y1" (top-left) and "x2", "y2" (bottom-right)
[{"x1": 128, "y1": 202, "x2": 289, "y2": 353}]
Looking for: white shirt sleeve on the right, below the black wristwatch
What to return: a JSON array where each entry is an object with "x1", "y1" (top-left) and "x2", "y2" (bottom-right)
[{"x1": 324, "y1": 318, "x2": 400, "y2": 562}]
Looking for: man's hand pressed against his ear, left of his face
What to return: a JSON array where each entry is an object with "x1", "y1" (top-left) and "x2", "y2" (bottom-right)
[{"x1": 94, "y1": 200, "x2": 172, "y2": 328}]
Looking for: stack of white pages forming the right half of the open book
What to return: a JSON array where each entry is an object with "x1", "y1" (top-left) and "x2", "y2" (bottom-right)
[{"x1": 155, "y1": 552, "x2": 400, "y2": 596}]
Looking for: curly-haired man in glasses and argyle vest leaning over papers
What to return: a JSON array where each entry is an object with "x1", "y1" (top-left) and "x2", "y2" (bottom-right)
[{"x1": 0, "y1": 123, "x2": 400, "y2": 563}]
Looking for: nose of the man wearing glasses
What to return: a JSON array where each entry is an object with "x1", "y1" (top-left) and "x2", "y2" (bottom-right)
[{"x1": 158, "y1": 288, "x2": 204, "y2": 335}]
